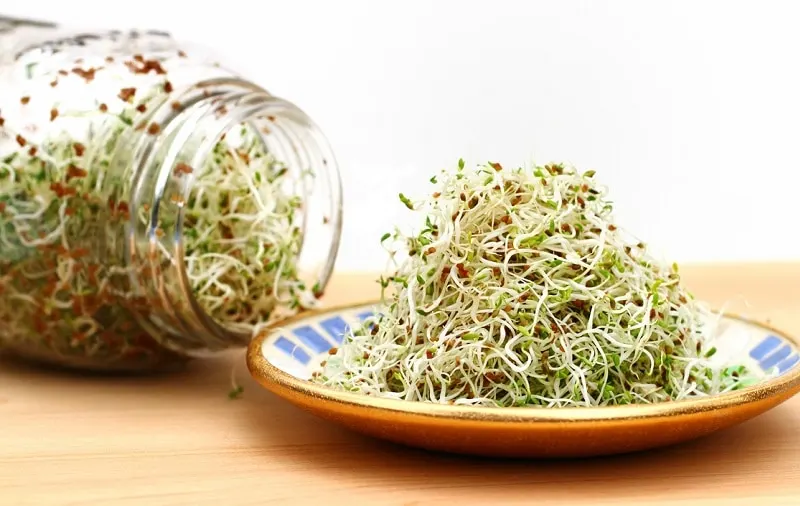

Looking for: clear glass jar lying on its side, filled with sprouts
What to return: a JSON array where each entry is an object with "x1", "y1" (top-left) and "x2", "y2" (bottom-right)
[{"x1": 0, "y1": 18, "x2": 341, "y2": 370}]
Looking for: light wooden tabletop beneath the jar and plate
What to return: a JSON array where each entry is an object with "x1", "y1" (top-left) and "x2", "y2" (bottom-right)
[{"x1": 0, "y1": 264, "x2": 800, "y2": 506}]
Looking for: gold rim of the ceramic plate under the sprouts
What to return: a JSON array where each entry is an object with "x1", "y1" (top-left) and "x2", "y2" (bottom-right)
[{"x1": 247, "y1": 300, "x2": 800, "y2": 424}]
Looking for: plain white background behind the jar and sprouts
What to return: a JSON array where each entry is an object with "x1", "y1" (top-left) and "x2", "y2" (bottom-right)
[{"x1": 0, "y1": 0, "x2": 800, "y2": 270}]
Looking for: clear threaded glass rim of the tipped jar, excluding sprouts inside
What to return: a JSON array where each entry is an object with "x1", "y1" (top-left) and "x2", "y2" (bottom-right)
[{"x1": 127, "y1": 79, "x2": 343, "y2": 353}]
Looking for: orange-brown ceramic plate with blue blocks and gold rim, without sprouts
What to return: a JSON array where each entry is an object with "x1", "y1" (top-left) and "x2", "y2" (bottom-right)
[{"x1": 247, "y1": 304, "x2": 800, "y2": 457}]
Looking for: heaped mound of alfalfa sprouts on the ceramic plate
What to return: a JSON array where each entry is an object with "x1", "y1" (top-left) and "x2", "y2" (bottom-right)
[{"x1": 314, "y1": 161, "x2": 748, "y2": 407}]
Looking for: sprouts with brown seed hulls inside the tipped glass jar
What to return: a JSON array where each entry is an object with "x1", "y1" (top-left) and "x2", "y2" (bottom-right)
[{"x1": 0, "y1": 33, "x2": 319, "y2": 367}]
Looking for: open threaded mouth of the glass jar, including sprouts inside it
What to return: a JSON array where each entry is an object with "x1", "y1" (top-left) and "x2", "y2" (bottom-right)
[{"x1": 132, "y1": 80, "x2": 342, "y2": 351}]
